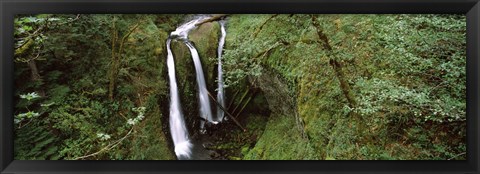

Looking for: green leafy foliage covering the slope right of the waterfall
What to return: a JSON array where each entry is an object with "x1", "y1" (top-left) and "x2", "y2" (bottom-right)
[{"x1": 225, "y1": 15, "x2": 466, "y2": 159}]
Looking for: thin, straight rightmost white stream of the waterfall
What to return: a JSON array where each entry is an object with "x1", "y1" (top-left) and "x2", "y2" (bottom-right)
[{"x1": 217, "y1": 20, "x2": 227, "y2": 122}]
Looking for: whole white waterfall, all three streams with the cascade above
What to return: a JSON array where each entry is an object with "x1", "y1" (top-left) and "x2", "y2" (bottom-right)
[{"x1": 166, "y1": 16, "x2": 230, "y2": 159}]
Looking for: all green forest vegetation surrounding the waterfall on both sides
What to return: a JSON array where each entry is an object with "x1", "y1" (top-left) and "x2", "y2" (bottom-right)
[{"x1": 14, "y1": 14, "x2": 466, "y2": 160}]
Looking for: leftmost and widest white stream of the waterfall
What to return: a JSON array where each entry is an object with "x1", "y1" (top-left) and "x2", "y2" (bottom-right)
[{"x1": 166, "y1": 39, "x2": 192, "y2": 159}]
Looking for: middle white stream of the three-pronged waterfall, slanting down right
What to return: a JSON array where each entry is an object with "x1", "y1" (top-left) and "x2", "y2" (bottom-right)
[{"x1": 185, "y1": 41, "x2": 218, "y2": 130}]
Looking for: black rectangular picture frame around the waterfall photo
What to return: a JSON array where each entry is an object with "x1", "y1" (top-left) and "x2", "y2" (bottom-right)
[{"x1": 0, "y1": 0, "x2": 480, "y2": 174}]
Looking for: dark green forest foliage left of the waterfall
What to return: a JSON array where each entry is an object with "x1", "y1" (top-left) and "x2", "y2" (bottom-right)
[{"x1": 15, "y1": 14, "x2": 173, "y2": 160}]
